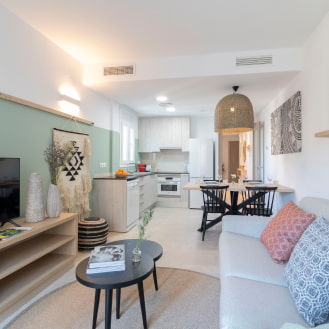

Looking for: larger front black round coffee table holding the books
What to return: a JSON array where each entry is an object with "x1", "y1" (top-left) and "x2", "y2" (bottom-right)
[{"x1": 76, "y1": 240, "x2": 154, "y2": 329}]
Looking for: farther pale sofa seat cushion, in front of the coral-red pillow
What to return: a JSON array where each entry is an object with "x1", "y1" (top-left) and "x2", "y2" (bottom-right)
[{"x1": 219, "y1": 231, "x2": 287, "y2": 286}]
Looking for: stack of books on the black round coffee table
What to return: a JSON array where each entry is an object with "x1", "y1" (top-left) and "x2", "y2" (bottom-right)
[{"x1": 87, "y1": 244, "x2": 126, "y2": 274}]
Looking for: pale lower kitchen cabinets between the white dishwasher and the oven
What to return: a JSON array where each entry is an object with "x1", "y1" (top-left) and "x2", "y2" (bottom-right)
[{"x1": 139, "y1": 175, "x2": 157, "y2": 217}]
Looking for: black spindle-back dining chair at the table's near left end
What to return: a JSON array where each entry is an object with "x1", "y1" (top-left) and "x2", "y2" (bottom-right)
[{"x1": 200, "y1": 185, "x2": 229, "y2": 241}]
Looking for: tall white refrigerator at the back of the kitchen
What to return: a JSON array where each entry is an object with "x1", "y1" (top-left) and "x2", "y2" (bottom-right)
[{"x1": 189, "y1": 138, "x2": 215, "y2": 209}]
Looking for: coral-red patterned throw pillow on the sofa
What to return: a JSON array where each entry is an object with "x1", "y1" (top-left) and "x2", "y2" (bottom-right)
[{"x1": 260, "y1": 201, "x2": 316, "y2": 263}]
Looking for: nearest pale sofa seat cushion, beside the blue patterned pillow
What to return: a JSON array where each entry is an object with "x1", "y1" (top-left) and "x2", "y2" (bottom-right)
[{"x1": 219, "y1": 276, "x2": 307, "y2": 329}]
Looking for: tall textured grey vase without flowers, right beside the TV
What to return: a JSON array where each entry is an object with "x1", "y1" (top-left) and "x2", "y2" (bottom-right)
[{"x1": 25, "y1": 173, "x2": 45, "y2": 223}]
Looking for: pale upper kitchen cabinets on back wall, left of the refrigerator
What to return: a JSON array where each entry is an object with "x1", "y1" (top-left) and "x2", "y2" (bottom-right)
[{"x1": 139, "y1": 117, "x2": 190, "y2": 152}]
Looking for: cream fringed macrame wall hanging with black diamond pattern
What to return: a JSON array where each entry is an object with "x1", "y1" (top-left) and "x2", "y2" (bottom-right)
[{"x1": 53, "y1": 128, "x2": 91, "y2": 219}]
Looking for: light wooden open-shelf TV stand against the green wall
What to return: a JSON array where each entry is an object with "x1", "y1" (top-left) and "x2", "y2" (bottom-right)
[{"x1": 0, "y1": 213, "x2": 78, "y2": 322}]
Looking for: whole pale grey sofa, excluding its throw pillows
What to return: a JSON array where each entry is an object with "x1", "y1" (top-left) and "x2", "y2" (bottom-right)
[{"x1": 219, "y1": 197, "x2": 329, "y2": 329}]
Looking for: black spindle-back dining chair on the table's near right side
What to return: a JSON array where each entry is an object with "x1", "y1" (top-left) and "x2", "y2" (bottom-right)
[{"x1": 242, "y1": 185, "x2": 278, "y2": 217}]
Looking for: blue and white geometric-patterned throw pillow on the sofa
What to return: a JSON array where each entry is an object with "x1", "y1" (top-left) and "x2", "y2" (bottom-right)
[{"x1": 284, "y1": 217, "x2": 329, "y2": 327}]
